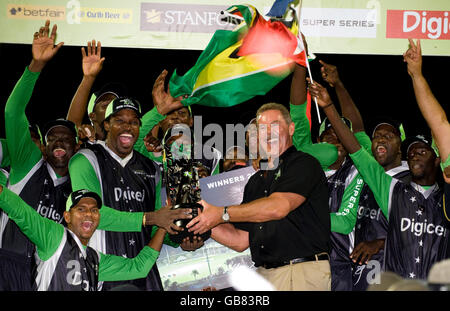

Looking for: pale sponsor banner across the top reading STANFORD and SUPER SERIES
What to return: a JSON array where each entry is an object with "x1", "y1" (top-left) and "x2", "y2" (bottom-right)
[{"x1": 0, "y1": 0, "x2": 450, "y2": 55}]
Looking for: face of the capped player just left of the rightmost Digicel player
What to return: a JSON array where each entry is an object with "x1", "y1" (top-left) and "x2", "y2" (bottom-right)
[{"x1": 372, "y1": 124, "x2": 402, "y2": 170}]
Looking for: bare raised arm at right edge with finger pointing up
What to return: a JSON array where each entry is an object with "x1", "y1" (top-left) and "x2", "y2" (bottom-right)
[{"x1": 403, "y1": 39, "x2": 450, "y2": 178}]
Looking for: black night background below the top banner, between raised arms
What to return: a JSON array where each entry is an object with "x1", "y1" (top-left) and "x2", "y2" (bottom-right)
[{"x1": 0, "y1": 39, "x2": 450, "y2": 143}]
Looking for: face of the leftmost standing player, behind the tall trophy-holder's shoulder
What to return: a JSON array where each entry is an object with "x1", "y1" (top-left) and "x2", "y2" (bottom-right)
[{"x1": 45, "y1": 126, "x2": 77, "y2": 170}]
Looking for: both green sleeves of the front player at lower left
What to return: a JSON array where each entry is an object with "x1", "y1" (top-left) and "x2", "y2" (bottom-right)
[{"x1": 0, "y1": 188, "x2": 159, "y2": 281}]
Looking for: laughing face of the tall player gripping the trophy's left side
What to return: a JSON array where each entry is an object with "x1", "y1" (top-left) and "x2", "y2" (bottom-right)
[{"x1": 104, "y1": 109, "x2": 140, "y2": 158}]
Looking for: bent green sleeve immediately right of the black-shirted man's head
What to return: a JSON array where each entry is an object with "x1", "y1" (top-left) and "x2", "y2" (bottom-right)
[{"x1": 290, "y1": 104, "x2": 338, "y2": 169}]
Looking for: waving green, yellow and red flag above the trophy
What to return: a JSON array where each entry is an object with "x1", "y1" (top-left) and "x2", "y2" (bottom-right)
[{"x1": 169, "y1": 5, "x2": 306, "y2": 107}]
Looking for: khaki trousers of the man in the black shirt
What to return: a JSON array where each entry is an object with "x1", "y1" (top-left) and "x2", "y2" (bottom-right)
[{"x1": 256, "y1": 260, "x2": 331, "y2": 291}]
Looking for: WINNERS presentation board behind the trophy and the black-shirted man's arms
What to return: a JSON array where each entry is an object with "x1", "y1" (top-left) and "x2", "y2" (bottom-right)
[{"x1": 157, "y1": 167, "x2": 255, "y2": 291}]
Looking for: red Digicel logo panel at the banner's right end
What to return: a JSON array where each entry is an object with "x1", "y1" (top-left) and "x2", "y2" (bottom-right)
[{"x1": 386, "y1": 10, "x2": 450, "y2": 40}]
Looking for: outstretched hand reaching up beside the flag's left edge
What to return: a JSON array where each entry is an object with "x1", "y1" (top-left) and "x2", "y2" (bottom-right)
[{"x1": 152, "y1": 69, "x2": 183, "y2": 115}]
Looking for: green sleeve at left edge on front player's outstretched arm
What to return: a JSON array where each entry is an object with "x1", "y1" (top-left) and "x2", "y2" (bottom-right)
[{"x1": 0, "y1": 188, "x2": 64, "y2": 261}]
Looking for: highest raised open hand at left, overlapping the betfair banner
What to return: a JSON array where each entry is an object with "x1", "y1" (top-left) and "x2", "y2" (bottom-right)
[{"x1": 29, "y1": 20, "x2": 64, "y2": 72}]
